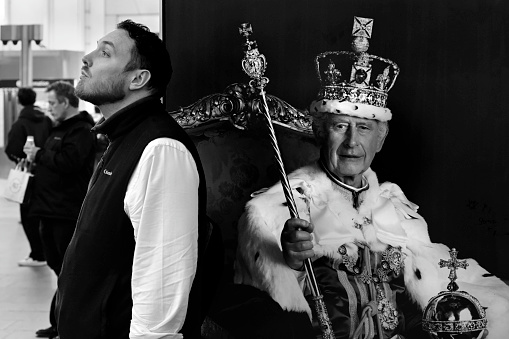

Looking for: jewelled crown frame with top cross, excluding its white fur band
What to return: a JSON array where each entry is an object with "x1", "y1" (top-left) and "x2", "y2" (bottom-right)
[{"x1": 315, "y1": 17, "x2": 399, "y2": 108}]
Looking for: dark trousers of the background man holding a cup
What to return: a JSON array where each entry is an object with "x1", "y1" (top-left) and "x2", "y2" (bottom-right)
[{"x1": 40, "y1": 218, "x2": 76, "y2": 328}]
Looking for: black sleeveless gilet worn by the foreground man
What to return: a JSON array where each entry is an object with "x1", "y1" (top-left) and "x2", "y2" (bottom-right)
[{"x1": 56, "y1": 97, "x2": 206, "y2": 339}]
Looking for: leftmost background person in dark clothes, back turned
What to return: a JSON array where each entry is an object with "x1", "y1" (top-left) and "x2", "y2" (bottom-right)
[{"x1": 5, "y1": 87, "x2": 52, "y2": 267}]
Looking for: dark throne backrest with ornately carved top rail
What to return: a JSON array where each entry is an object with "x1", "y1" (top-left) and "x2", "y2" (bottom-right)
[{"x1": 170, "y1": 84, "x2": 319, "y2": 279}]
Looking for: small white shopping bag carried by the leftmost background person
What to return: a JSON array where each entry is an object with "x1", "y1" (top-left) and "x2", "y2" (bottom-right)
[{"x1": 4, "y1": 159, "x2": 33, "y2": 204}]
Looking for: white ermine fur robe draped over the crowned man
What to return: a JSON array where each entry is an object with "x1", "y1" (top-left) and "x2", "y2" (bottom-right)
[{"x1": 235, "y1": 164, "x2": 509, "y2": 339}]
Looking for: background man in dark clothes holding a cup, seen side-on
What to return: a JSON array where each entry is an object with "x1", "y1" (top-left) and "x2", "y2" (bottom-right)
[{"x1": 23, "y1": 81, "x2": 96, "y2": 338}]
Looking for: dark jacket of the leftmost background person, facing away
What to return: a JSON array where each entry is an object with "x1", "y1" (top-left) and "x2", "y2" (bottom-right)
[{"x1": 5, "y1": 105, "x2": 53, "y2": 163}]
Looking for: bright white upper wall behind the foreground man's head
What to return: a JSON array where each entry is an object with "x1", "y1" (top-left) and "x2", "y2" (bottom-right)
[{"x1": 0, "y1": 0, "x2": 159, "y2": 53}]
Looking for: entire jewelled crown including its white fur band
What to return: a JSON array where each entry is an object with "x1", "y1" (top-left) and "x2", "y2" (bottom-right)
[{"x1": 309, "y1": 17, "x2": 399, "y2": 121}]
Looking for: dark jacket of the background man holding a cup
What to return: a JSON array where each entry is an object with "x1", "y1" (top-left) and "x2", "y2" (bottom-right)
[{"x1": 30, "y1": 111, "x2": 96, "y2": 220}]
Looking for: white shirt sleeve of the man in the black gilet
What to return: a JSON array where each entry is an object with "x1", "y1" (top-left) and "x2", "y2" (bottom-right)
[{"x1": 124, "y1": 138, "x2": 199, "y2": 339}]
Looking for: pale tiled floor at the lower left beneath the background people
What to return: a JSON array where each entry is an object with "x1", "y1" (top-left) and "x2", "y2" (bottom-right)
[{"x1": 0, "y1": 179, "x2": 56, "y2": 339}]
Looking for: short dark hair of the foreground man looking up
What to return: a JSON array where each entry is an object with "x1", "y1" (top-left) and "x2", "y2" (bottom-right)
[{"x1": 117, "y1": 20, "x2": 172, "y2": 96}]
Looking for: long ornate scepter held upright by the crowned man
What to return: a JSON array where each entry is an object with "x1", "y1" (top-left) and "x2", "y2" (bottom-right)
[{"x1": 239, "y1": 23, "x2": 335, "y2": 339}]
